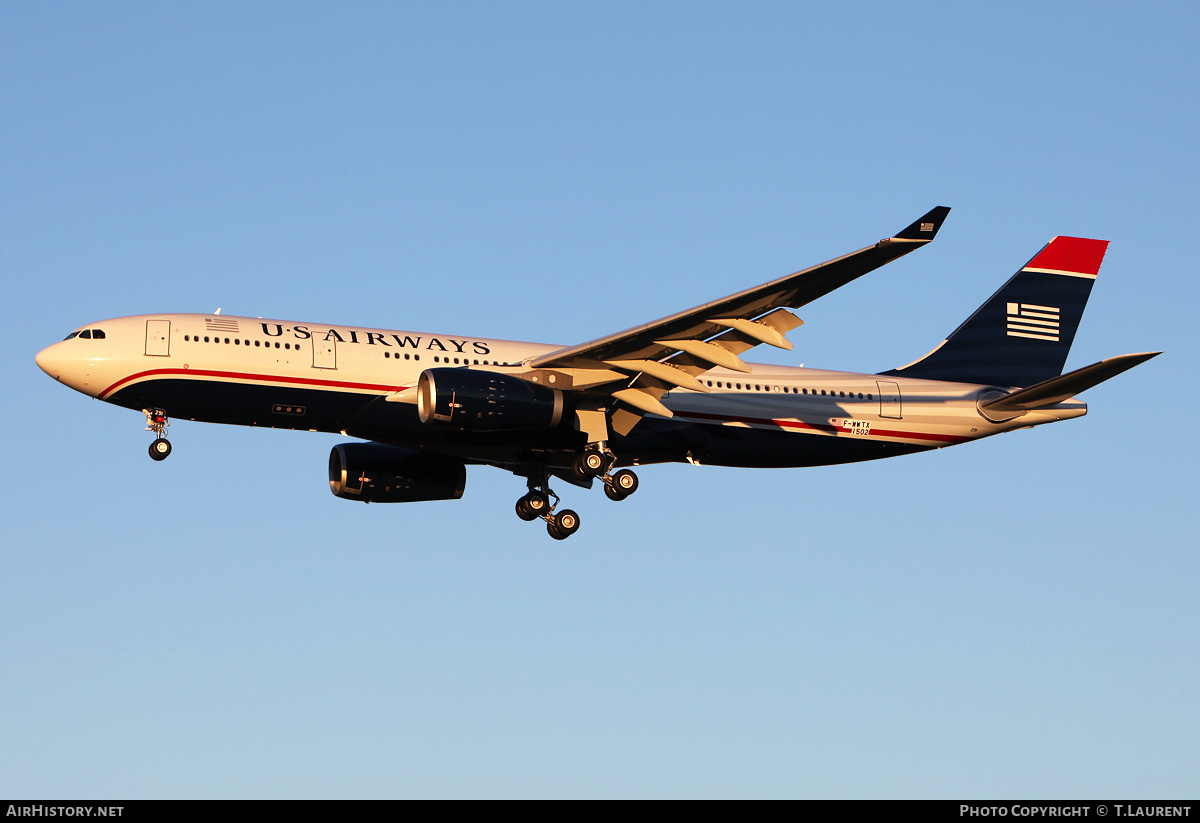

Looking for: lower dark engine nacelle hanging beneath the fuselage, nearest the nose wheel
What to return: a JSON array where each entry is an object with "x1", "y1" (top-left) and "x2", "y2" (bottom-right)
[{"x1": 329, "y1": 443, "x2": 467, "y2": 503}]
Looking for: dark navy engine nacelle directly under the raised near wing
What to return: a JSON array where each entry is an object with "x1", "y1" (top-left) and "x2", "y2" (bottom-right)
[{"x1": 416, "y1": 368, "x2": 563, "y2": 432}]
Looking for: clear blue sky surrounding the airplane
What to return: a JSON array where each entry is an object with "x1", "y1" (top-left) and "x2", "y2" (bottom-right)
[{"x1": 0, "y1": 2, "x2": 1200, "y2": 798}]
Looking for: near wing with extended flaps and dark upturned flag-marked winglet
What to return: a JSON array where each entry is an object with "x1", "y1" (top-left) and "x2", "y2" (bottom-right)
[{"x1": 528, "y1": 206, "x2": 950, "y2": 433}]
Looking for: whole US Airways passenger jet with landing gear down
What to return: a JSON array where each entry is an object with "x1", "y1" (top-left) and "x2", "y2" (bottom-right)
[{"x1": 36, "y1": 206, "x2": 1160, "y2": 540}]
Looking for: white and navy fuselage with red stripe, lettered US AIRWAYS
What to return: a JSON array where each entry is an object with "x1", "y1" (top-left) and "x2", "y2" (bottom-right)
[{"x1": 37, "y1": 314, "x2": 1086, "y2": 465}]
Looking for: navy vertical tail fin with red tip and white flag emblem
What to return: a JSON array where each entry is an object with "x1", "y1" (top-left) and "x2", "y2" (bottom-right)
[{"x1": 884, "y1": 238, "x2": 1109, "y2": 386}]
